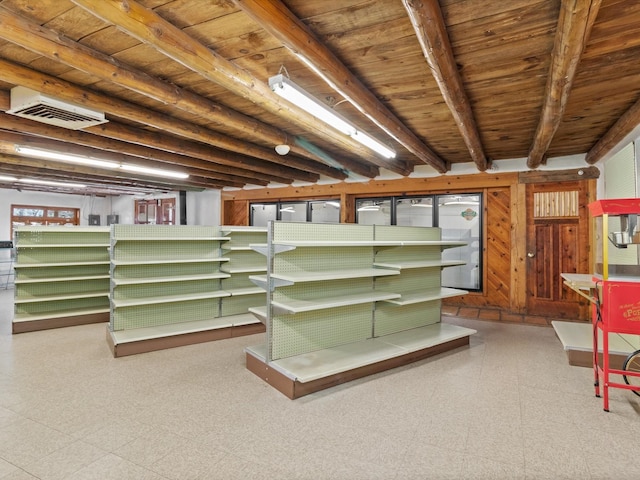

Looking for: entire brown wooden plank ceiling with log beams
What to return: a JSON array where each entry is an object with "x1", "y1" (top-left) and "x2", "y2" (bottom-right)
[{"x1": 0, "y1": 0, "x2": 640, "y2": 195}]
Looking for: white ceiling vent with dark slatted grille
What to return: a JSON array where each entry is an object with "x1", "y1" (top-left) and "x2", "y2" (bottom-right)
[{"x1": 7, "y1": 87, "x2": 108, "y2": 130}]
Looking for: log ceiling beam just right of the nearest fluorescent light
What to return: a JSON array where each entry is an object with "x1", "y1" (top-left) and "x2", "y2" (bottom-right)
[{"x1": 234, "y1": 0, "x2": 448, "y2": 173}]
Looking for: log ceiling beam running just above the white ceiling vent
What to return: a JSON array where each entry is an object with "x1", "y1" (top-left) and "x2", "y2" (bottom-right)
[{"x1": 0, "y1": 59, "x2": 348, "y2": 181}]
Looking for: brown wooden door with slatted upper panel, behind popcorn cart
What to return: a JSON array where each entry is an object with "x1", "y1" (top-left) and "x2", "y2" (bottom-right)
[{"x1": 526, "y1": 182, "x2": 589, "y2": 320}]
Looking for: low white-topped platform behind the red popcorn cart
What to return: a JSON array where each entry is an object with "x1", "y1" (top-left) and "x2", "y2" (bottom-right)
[{"x1": 551, "y1": 321, "x2": 640, "y2": 370}]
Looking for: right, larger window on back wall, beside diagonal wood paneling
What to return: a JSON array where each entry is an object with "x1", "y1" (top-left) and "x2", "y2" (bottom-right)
[{"x1": 356, "y1": 193, "x2": 482, "y2": 291}]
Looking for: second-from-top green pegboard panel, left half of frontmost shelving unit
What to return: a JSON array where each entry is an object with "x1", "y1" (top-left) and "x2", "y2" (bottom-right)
[{"x1": 273, "y1": 247, "x2": 373, "y2": 274}]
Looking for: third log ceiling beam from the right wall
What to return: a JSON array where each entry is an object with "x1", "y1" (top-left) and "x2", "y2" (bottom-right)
[{"x1": 402, "y1": 0, "x2": 489, "y2": 172}]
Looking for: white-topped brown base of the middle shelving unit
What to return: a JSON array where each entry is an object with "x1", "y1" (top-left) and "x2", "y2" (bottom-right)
[{"x1": 107, "y1": 313, "x2": 265, "y2": 358}]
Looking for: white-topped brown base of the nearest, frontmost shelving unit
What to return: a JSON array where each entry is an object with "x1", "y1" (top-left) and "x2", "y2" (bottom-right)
[{"x1": 245, "y1": 323, "x2": 476, "y2": 400}]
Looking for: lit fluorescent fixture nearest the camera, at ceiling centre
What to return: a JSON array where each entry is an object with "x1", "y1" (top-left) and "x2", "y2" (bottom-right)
[{"x1": 269, "y1": 74, "x2": 396, "y2": 159}]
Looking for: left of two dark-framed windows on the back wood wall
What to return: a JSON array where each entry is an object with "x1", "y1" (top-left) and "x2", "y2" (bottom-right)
[{"x1": 249, "y1": 200, "x2": 340, "y2": 227}]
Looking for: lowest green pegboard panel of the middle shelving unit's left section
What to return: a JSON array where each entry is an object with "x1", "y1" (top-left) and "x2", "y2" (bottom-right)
[{"x1": 110, "y1": 298, "x2": 220, "y2": 331}]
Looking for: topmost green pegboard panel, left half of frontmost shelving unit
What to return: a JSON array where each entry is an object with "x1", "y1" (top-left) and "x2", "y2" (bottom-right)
[{"x1": 273, "y1": 222, "x2": 373, "y2": 242}]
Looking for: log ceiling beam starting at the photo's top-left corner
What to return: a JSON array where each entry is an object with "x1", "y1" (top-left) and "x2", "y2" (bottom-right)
[{"x1": 0, "y1": 6, "x2": 330, "y2": 164}]
